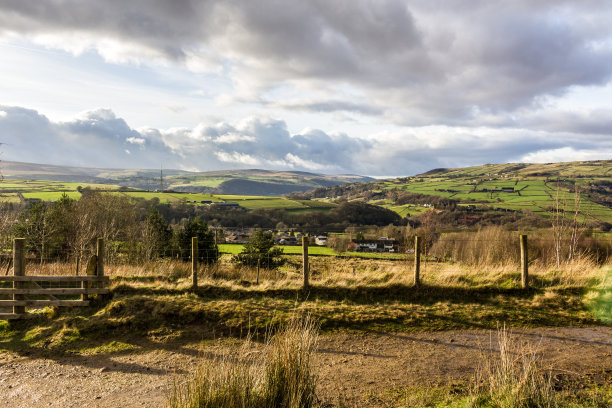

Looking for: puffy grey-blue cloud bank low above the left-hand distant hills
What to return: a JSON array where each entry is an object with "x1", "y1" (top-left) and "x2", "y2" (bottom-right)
[{"x1": 0, "y1": 106, "x2": 367, "y2": 172}]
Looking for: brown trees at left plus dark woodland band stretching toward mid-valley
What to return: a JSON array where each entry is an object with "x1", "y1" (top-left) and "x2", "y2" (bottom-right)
[{"x1": 0, "y1": 191, "x2": 403, "y2": 264}]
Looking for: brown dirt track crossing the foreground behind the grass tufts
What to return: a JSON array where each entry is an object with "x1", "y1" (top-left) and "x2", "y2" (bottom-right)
[{"x1": 0, "y1": 327, "x2": 612, "y2": 408}]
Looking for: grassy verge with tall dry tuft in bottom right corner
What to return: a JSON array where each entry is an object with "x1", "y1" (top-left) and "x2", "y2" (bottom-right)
[{"x1": 387, "y1": 327, "x2": 612, "y2": 408}]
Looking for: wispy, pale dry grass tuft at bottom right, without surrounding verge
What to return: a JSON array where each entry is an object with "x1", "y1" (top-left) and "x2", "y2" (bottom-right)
[{"x1": 472, "y1": 327, "x2": 558, "y2": 408}]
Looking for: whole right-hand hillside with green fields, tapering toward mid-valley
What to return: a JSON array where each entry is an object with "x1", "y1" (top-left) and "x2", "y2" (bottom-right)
[{"x1": 304, "y1": 160, "x2": 612, "y2": 223}]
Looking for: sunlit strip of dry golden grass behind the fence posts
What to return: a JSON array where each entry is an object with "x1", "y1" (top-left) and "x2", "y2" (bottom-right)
[{"x1": 17, "y1": 250, "x2": 612, "y2": 290}]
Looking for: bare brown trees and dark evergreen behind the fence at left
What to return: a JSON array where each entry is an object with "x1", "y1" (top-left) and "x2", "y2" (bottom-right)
[{"x1": 0, "y1": 193, "x2": 219, "y2": 262}]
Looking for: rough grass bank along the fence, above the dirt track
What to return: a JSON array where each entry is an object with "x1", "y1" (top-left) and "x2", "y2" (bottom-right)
[{"x1": 0, "y1": 255, "x2": 610, "y2": 353}]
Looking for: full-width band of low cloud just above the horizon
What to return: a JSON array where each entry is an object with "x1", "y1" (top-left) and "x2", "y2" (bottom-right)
[{"x1": 0, "y1": 106, "x2": 612, "y2": 176}]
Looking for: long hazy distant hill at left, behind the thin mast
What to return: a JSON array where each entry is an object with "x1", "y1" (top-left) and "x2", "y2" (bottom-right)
[{"x1": 0, "y1": 161, "x2": 373, "y2": 196}]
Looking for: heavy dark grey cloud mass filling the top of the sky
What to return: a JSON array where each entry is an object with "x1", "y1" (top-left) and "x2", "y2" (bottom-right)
[{"x1": 0, "y1": 0, "x2": 612, "y2": 121}]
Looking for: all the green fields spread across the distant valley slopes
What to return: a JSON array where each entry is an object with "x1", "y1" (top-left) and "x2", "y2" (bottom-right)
[{"x1": 0, "y1": 161, "x2": 612, "y2": 222}]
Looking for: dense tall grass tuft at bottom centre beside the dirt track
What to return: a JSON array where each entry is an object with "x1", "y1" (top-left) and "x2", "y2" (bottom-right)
[{"x1": 168, "y1": 318, "x2": 318, "y2": 408}]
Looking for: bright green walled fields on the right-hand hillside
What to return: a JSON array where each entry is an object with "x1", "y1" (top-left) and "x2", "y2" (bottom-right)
[{"x1": 372, "y1": 161, "x2": 612, "y2": 222}]
